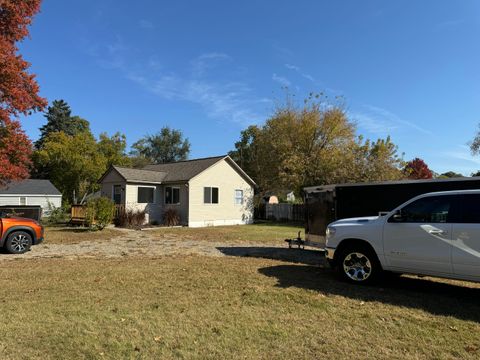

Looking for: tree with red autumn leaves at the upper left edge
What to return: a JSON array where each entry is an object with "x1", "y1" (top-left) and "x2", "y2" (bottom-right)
[{"x1": 0, "y1": 0, "x2": 47, "y2": 184}]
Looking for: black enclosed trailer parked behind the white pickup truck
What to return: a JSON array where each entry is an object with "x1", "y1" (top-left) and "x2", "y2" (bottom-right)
[{"x1": 298, "y1": 177, "x2": 480, "y2": 248}]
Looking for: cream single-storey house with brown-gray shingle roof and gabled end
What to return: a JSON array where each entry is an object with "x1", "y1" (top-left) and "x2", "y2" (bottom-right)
[{"x1": 95, "y1": 156, "x2": 256, "y2": 227}]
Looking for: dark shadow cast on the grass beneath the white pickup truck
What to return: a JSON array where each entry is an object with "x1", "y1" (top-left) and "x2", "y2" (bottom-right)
[{"x1": 259, "y1": 265, "x2": 480, "y2": 323}]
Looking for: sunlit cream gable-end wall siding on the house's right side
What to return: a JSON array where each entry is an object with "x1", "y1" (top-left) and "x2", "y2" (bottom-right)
[{"x1": 188, "y1": 160, "x2": 253, "y2": 227}]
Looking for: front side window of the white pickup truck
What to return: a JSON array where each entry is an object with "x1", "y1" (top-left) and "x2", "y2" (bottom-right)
[{"x1": 389, "y1": 196, "x2": 453, "y2": 223}]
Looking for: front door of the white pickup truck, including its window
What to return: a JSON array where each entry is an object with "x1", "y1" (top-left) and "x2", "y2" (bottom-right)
[{"x1": 383, "y1": 195, "x2": 454, "y2": 275}]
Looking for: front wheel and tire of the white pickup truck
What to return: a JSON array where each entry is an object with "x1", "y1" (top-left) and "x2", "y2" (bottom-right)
[{"x1": 336, "y1": 245, "x2": 382, "y2": 284}]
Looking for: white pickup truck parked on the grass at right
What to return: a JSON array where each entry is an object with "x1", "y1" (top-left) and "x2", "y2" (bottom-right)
[{"x1": 325, "y1": 190, "x2": 480, "y2": 283}]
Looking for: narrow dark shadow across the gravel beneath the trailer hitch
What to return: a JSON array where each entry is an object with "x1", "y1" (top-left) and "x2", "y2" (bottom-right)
[{"x1": 217, "y1": 246, "x2": 326, "y2": 267}]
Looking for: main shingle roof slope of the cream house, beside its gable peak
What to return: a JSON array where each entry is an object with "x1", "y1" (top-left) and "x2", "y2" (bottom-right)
[{"x1": 144, "y1": 155, "x2": 226, "y2": 182}]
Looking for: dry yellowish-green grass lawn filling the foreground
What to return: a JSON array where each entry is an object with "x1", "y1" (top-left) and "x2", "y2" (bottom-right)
[{"x1": 0, "y1": 226, "x2": 480, "y2": 359}]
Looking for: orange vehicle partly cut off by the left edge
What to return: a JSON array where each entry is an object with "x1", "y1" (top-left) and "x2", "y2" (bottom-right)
[{"x1": 0, "y1": 215, "x2": 44, "y2": 254}]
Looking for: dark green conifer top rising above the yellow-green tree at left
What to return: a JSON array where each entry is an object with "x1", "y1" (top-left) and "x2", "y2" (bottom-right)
[{"x1": 35, "y1": 100, "x2": 90, "y2": 149}]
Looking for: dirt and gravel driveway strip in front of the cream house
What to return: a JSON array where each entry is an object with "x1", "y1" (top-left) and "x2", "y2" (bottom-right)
[{"x1": 0, "y1": 226, "x2": 324, "y2": 265}]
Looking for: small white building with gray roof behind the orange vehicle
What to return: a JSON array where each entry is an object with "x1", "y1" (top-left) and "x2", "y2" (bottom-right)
[{"x1": 0, "y1": 179, "x2": 62, "y2": 216}]
